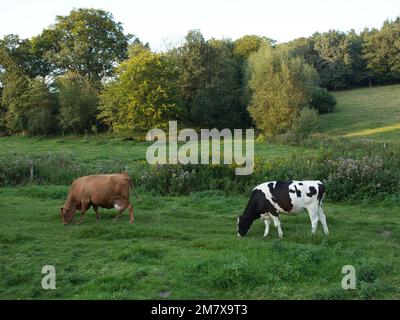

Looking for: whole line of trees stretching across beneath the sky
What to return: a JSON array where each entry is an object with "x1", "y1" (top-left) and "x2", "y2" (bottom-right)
[{"x1": 0, "y1": 9, "x2": 400, "y2": 135}]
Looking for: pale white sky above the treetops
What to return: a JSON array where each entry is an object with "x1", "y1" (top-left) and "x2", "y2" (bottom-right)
[{"x1": 0, "y1": 0, "x2": 400, "y2": 50}]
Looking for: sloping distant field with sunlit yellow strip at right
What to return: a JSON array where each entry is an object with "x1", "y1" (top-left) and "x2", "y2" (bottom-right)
[{"x1": 321, "y1": 85, "x2": 400, "y2": 142}]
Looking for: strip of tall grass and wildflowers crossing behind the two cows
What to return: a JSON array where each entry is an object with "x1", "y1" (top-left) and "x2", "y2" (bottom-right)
[{"x1": 0, "y1": 140, "x2": 400, "y2": 200}]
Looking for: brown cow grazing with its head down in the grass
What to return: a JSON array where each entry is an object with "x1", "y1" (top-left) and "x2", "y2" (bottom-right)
[{"x1": 60, "y1": 173, "x2": 133, "y2": 225}]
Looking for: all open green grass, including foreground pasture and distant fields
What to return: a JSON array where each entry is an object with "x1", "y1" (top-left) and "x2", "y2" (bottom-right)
[{"x1": 0, "y1": 86, "x2": 400, "y2": 299}]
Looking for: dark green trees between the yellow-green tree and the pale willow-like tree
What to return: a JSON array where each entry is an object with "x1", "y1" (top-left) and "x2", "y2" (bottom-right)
[{"x1": 175, "y1": 30, "x2": 247, "y2": 129}]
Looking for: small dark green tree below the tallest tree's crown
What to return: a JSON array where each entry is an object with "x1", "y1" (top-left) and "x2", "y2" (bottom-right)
[{"x1": 57, "y1": 72, "x2": 98, "y2": 134}]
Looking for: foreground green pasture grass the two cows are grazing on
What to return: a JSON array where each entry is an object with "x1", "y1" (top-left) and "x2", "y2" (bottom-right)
[{"x1": 0, "y1": 186, "x2": 400, "y2": 299}]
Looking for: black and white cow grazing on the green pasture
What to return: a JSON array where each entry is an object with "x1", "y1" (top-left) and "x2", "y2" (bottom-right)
[{"x1": 238, "y1": 181, "x2": 329, "y2": 238}]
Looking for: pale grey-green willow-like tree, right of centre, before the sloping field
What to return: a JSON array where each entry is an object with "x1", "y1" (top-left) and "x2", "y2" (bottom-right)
[{"x1": 248, "y1": 45, "x2": 318, "y2": 135}]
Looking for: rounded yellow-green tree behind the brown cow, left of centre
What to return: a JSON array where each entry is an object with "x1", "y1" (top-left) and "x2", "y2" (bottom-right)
[{"x1": 98, "y1": 46, "x2": 181, "y2": 134}]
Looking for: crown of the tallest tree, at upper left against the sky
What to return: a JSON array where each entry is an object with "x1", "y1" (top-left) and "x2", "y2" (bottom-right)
[{"x1": 33, "y1": 9, "x2": 133, "y2": 83}]
